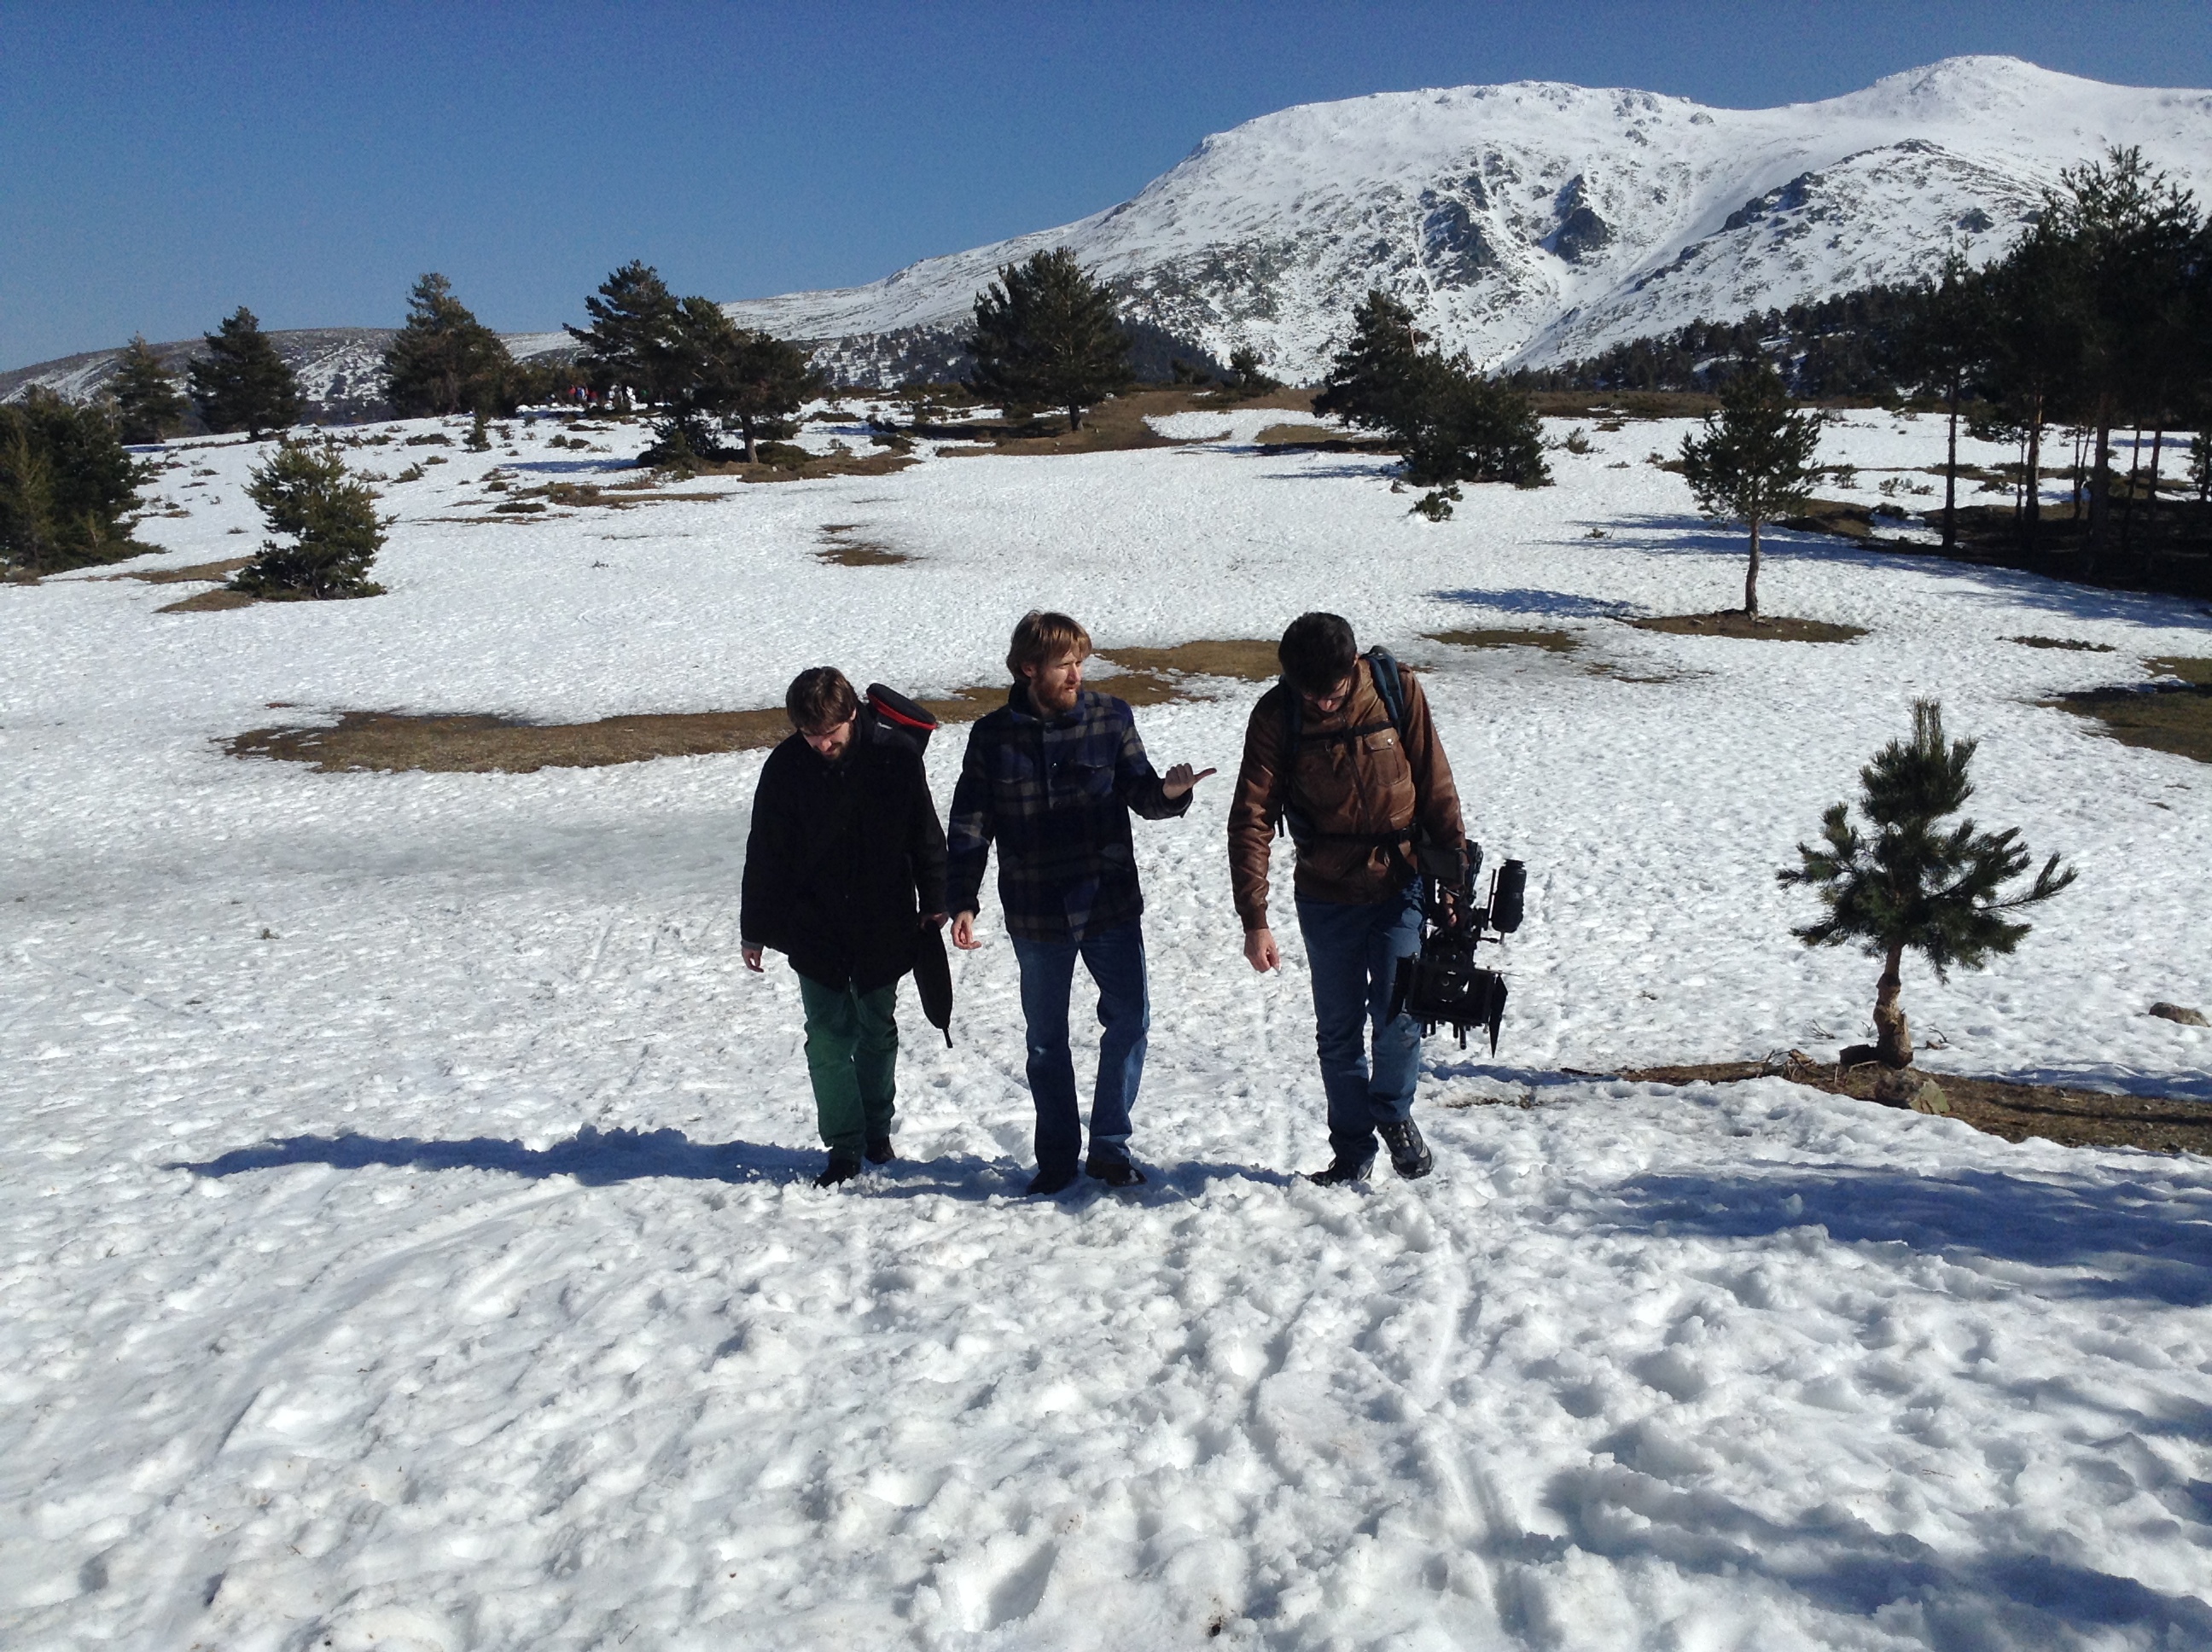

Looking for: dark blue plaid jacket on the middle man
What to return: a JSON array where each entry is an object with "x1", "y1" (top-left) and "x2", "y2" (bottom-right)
[{"x1": 945, "y1": 683, "x2": 1190, "y2": 939}]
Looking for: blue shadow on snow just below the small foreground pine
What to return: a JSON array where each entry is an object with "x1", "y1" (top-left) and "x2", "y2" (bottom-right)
[{"x1": 1599, "y1": 1166, "x2": 2212, "y2": 1307}]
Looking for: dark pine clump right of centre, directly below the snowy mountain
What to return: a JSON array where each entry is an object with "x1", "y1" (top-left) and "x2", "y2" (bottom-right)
[{"x1": 1314, "y1": 290, "x2": 1551, "y2": 522}]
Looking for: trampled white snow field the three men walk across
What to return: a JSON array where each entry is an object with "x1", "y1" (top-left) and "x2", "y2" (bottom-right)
[{"x1": 0, "y1": 414, "x2": 2212, "y2": 1652}]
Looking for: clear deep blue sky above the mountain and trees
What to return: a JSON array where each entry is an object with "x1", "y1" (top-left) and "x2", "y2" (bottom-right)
[{"x1": 13, "y1": 0, "x2": 2212, "y2": 367}]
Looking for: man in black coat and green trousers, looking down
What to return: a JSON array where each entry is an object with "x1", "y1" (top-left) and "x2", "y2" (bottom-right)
[{"x1": 736, "y1": 666, "x2": 945, "y2": 1188}]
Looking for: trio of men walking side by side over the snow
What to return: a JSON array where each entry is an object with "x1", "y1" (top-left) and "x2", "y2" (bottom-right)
[{"x1": 739, "y1": 613, "x2": 1466, "y2": 1195}]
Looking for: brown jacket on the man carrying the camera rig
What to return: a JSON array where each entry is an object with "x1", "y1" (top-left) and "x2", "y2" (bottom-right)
[{"x1": 1230, "y1": 657, "x2": 1466, "y2": 931}]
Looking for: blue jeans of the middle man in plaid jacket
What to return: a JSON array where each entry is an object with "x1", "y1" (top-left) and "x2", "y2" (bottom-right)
[{"x1": 1013, "y1": 918, "x2": 1152, "y2": 1174}]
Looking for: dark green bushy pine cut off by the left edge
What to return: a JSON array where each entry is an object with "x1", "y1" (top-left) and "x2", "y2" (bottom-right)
[{"x1": 0, "y1": 387, "x2": 146, "y2": 573}]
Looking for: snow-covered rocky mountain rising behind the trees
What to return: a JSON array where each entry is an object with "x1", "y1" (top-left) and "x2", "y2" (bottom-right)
[{"x1": 728, "y1": 57, "x2": 2212, "y2": 378}]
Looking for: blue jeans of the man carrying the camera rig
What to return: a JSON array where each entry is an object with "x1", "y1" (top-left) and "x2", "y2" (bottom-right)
[{"x1": 1299, "y1": 885, "x2": 1420, "y2": 1161}]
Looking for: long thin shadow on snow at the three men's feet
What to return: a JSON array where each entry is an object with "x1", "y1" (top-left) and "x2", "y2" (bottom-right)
[{"x1": 177, "y1": 1124, "x2": 1289, "y2": 1205}]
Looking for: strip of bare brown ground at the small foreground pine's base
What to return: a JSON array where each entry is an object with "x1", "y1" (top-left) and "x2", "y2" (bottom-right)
[{"x1": 1617, "y1": 1050, "x2": 2212, "y2": 1152}]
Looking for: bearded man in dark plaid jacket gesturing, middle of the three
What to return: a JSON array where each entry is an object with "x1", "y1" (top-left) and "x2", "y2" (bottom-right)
[{"x1": 945, "y1": 613, "x2": 1212, "y2": 1195}]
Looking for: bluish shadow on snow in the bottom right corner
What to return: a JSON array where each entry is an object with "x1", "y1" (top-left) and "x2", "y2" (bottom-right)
[{"x1": 1544, "y1": 1464, "x2": 2212, "y2": 1645}]
